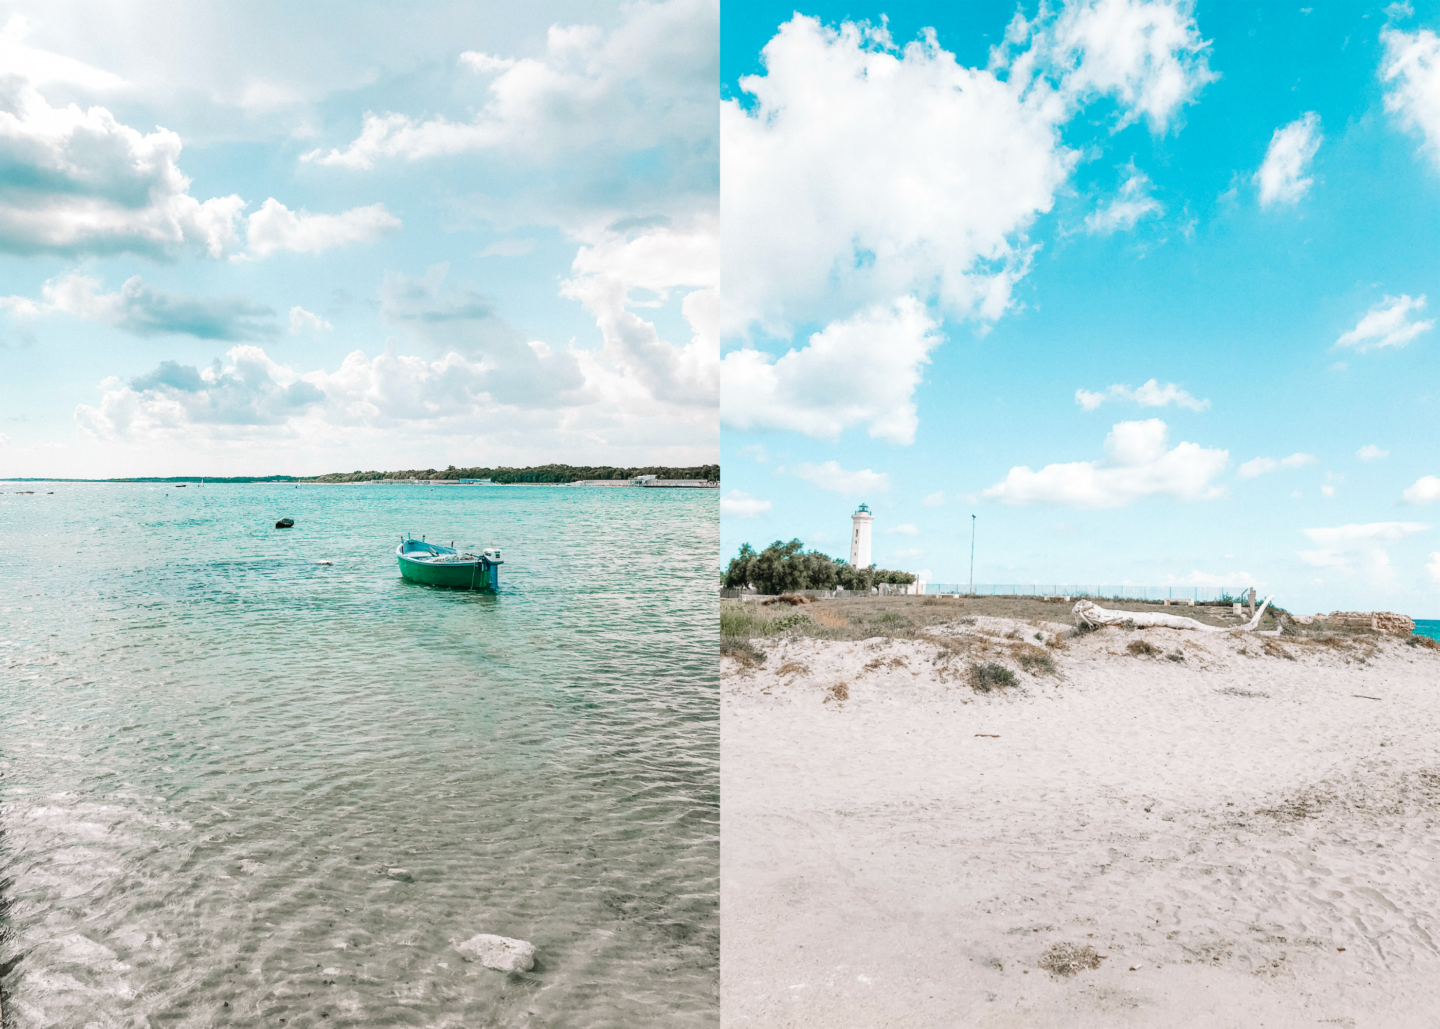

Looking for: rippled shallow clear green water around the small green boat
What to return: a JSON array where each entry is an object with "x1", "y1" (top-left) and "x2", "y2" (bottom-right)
[{"x1": 0, "y1": 484, "x2": 719, "y2": 1029}]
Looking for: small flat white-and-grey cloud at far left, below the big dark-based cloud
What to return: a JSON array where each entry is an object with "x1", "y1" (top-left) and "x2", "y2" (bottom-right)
[{"x1": 0, "y1": 273, "x2": 275, "y2": 340}]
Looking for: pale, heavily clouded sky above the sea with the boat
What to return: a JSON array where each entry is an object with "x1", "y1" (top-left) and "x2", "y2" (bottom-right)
[{"x1": 0, "y1": 0, "x2": 719, "y2": 476}]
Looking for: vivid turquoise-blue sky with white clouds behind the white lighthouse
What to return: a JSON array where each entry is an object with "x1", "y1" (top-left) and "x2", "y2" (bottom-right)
[{"x1": 720, "y1": 0, "x2": 1440, "y2": 617}]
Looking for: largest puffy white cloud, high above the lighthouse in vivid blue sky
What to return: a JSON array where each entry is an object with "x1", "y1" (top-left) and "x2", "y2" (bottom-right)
[{"x1": 720, "y1": 14, "x2": 1074, "y2": 335}]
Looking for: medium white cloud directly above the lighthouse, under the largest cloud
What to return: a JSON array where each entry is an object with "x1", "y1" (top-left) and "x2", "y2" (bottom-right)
[{"x1": 720, "y1": 296, "x2": 943, "y2": 443}]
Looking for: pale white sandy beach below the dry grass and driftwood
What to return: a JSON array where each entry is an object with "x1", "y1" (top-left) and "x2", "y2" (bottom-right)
[{"x1": 721, "y1": 619, "x2": 1440, "y2": 1029}]
